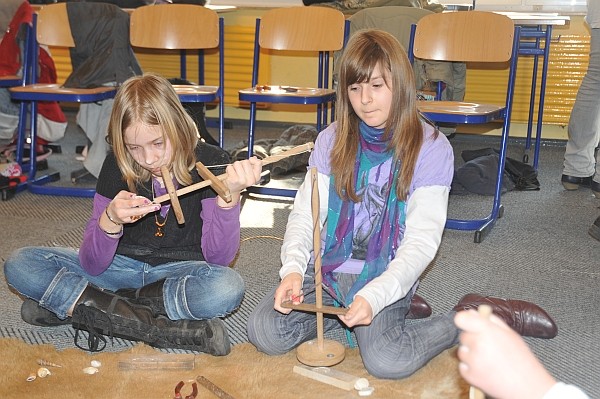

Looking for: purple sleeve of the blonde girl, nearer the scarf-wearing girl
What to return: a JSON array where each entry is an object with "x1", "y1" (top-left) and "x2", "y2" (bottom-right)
[{"x1": 200, "y1": 198, "x2": 241, "y2": 266}]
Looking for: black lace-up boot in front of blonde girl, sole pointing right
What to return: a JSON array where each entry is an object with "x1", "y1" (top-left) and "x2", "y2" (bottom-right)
[{"x1": 72, "y1": 286, "x2": 231, "y2": 356}]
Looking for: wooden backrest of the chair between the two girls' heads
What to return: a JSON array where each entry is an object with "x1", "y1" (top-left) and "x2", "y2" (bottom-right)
[{"x1": 259, "y1": 7, "x2": 345, "y2": 51}]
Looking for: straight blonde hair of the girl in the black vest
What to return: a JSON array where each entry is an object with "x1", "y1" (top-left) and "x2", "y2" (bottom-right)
[{"x1": 108, "y1": 73, "x2": 199, "y2": 192}]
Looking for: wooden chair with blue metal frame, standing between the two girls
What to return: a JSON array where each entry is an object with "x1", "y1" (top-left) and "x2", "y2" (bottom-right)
[{"x1": 239, "y1": 7, "x2": 346, "y2": 197}]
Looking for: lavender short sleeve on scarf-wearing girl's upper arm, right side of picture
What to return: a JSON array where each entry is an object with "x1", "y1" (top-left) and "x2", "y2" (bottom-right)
[{"x1": 410, "y1": 124, "x2": 454, "y2": 194}]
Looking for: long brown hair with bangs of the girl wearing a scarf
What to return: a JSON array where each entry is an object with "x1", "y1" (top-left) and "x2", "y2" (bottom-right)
[{"x1": 331, "y1": 29, "x2": 423, "y2": 202}]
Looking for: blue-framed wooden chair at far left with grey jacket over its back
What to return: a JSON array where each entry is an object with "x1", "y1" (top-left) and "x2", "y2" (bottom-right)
[{"x1": 10, "y1": 3, "x2": 117, "y2": 197}]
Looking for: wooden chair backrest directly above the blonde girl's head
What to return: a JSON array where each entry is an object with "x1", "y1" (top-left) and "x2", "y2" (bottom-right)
[{"x1": 129, "y1": 4, "x2": 219, "y2": 50}]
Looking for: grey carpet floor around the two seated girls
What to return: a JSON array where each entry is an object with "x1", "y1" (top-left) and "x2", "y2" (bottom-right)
[{"x1": 0, "y1": 113, "x2": 600, "y2": 398}]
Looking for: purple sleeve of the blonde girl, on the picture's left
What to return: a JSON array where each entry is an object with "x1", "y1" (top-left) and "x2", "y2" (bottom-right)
[{"x1": 79, "y1": 194, "x2": 121, "y2": 276}]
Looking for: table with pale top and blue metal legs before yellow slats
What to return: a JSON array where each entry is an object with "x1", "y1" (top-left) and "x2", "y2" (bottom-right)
[{"x1": 496, "y1": 11, "x2": 570, "y2": 170}]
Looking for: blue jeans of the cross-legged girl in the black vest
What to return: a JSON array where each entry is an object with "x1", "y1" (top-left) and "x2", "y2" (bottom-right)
[{"x1": 4, "y1": 247, "x2": 244, "y2": 320}]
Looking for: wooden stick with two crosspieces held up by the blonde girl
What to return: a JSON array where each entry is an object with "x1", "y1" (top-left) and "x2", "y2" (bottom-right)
[{"x1": 154, "y1": 142, "x2": 315, "y2": 224}]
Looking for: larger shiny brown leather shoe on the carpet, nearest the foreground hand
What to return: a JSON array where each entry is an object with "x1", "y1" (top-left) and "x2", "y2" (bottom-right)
[{"x1": 453, "y1": 294, "x2": 558, "y2": 338}]
